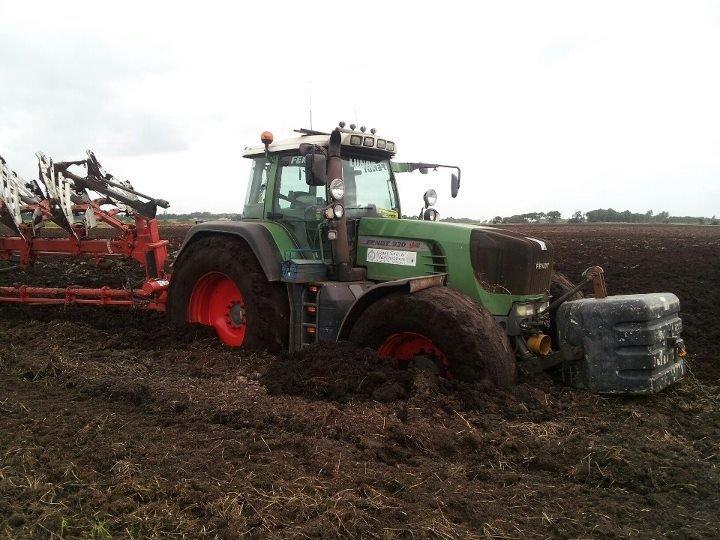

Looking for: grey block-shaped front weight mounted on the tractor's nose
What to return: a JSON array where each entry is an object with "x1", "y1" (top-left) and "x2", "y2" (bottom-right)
[{"x1": 556, "y1": 293, "x2": 685, "y2": 394}]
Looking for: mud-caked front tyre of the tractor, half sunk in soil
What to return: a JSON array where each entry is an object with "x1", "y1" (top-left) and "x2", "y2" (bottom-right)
[{"x1": 349, "y1": 287, "x2": 516, "y2": 386}]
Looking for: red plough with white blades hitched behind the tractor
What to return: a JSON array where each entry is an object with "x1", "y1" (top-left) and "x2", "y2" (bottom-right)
[{"x1": 0, "y1": 151, "x2": 170, "y2": 311}]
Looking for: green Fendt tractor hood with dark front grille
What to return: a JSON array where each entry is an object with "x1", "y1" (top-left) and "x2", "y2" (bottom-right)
[{"x1": 356, "y1": 218, "x2": 553, "y2": 312}]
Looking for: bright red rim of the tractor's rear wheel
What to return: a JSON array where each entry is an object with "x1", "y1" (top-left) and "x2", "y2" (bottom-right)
[{"x1": 188, "y1": 272, "x2": 247, "y2": 347}]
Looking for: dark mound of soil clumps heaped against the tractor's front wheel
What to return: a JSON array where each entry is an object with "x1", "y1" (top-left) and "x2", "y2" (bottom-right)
[{"x1": 262, "y1": 342, "x2": 413, "y2": 402}]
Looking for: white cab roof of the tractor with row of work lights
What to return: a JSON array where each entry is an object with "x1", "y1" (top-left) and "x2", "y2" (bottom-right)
[{"x1": 243, "y1": 129, "x2": 397, "y2": 158}]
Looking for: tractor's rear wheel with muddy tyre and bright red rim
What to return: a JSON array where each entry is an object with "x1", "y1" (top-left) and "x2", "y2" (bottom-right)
[{"x1": 168, "y1": 236, "x2": 290, "y2": 352}]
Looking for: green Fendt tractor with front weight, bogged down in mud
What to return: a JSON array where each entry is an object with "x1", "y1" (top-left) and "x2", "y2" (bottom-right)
[{"x1": 168, "y1": 122, "x2": 684, "y2": 393}]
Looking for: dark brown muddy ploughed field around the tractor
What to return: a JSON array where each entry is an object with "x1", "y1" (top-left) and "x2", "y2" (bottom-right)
[{"x1": 0, "y1": 226, "x2": 720, "y2": 538}]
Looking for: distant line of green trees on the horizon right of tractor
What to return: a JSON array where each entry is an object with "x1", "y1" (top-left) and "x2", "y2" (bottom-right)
[{"x1": 443, "y1": 208, "x2": 720, "y2": 225}]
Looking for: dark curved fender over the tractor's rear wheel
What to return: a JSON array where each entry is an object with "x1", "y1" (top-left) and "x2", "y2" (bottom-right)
[{"x1": 175, "y1": 221, "x2": 291, "y2": 281}]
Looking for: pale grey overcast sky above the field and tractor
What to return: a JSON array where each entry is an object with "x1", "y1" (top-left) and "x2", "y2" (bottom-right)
[{"x1": 0, "y1": 0, "x2": 720, "y2": 219}]
